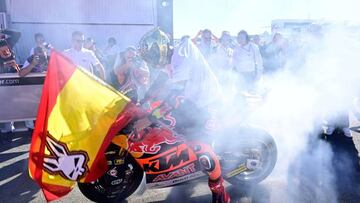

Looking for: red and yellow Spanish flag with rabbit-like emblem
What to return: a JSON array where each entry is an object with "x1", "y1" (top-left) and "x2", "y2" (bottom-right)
[{"x1": 29, "y1": 51, "x2": 130, "y2": 201}]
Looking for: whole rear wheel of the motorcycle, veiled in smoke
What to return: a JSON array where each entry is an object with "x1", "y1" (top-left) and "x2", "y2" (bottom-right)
[{"x1": 215, "y1": 127, "x2": 277, "y2": 186}]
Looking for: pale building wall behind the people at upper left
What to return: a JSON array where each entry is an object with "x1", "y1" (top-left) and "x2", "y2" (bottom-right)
[{"x1": 7, "y1": 0, "x2": 157, "y2": 62}]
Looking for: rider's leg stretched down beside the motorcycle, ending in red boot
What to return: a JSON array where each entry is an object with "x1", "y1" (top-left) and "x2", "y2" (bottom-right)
[{"x1": 166, "y1": 96, "x2": 230, "y2": 203}]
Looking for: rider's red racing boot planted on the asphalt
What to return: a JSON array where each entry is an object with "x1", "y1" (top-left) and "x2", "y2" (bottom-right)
[{"x1": 209, "y1": 177, "x2": 230, "y2": 203}]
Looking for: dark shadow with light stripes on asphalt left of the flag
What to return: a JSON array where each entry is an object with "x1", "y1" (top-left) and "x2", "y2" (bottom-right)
[{"x1": 0, "y1": 132, "x2": 39, "y2": 202}]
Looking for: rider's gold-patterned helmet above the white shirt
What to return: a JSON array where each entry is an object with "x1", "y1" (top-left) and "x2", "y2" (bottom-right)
[{"x1": 139, "y1": 28, "x2": 171, "y2": 67}]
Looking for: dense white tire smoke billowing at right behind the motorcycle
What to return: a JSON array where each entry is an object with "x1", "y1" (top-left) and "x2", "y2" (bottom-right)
[{"x1": 239, "y1": 27, "x2": 360, "y2": 201}]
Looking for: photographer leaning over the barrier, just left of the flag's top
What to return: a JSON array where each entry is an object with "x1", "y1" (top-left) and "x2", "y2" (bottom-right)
[{"x1": 19, "y1": 47, "x2": 49, "y2": 77}]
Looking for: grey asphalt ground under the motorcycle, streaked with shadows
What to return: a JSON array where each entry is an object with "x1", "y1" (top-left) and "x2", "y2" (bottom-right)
[{"x1": 0, "y1": 129, "x2": 360, "y2": 203}]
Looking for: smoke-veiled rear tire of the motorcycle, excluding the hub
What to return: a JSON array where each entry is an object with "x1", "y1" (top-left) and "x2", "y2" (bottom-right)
[{"x1": 220, "y1": 126, "x2": 277, "y2": 186}]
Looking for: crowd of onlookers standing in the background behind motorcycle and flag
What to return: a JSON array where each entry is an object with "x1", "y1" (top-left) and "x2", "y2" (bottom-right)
[{"x1": 0, "y1": 25, "x2": 334, "y2": 141}]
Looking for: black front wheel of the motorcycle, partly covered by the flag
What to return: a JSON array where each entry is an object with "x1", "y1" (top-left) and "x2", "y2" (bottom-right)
[{"x1": 78, "y1": 144, "x2": 143, "y2": 202}]
